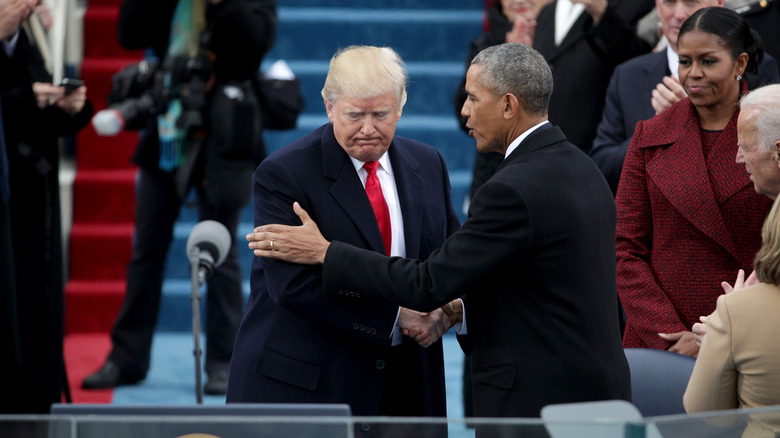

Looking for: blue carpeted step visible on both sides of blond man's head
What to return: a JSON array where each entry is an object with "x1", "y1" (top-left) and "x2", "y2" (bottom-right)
[{"x1": 264, "y1": 60, "x2": 466, "y2": 119}]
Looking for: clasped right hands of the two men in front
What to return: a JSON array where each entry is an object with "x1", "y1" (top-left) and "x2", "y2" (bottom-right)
[{"x1": 398, "y1": 299, "x2": 463, "y2": 348}]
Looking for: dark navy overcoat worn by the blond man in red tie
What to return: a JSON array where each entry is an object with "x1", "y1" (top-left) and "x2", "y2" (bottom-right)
[{"x1": 227, "y1": 124, "x2": 460, "y2": 416}]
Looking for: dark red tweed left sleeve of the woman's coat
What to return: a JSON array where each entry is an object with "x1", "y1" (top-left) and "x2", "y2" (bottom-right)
[{"x1": 615, "y1": 122, "x2": 690, "y2": 349}]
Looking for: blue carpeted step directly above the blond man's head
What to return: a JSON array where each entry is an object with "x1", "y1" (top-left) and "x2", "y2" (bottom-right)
[{"x1": 268, "y1": 6, "x2": 483, "y2": 62}]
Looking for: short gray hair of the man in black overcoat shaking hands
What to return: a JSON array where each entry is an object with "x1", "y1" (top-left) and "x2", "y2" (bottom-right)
[{"x1": 471, "y1": 43, "x2": 553, "y2": 116}]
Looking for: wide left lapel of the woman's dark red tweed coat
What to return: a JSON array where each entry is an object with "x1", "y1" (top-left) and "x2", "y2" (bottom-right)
[{"x1": 645, "y1": 99, "x2": 736, "y2": 255}]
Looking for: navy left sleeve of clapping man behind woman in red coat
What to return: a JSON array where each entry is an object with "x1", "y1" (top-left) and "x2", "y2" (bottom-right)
[{"x1": 590, "y1": 68, "x2": 631, "y2": 194}]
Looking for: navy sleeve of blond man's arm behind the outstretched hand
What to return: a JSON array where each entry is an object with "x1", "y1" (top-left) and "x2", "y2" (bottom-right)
[{"x1": 251, "y1": 158, "x2": 398, "y2": 345}]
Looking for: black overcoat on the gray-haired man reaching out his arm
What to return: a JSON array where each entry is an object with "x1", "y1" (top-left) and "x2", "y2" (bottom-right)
[{"x1": 323, "y1": 125, "x2": 631, "y2": 417}]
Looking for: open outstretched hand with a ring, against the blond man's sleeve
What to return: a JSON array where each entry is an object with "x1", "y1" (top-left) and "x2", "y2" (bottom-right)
[{"x1": 246, "y1": 202, "x2": 330, "y2": 265}]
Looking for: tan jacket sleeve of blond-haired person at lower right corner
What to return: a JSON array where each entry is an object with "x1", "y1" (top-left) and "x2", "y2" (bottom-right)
[{"x1": 683, "y1": 295, "x2": 739, "y2": 413}]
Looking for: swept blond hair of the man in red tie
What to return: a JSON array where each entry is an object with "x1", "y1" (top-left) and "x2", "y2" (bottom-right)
[{"x1": 321, "y1": 46, "x2": 409, "y2": 110}]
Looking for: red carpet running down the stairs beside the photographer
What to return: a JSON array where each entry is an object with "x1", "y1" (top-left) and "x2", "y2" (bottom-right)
[{"x1": 65, "y1": 0, "x2": 143, "y2": 403}]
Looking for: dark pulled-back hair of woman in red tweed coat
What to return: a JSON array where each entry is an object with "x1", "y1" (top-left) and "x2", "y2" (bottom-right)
[{"x1": 677, "y1": 6, "x2": 764, "y2": 73}]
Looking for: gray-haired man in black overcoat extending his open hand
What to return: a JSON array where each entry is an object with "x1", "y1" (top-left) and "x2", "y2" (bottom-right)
[{"x1": 247, "y1": 43, "x2": 631, "y2": 420}]
